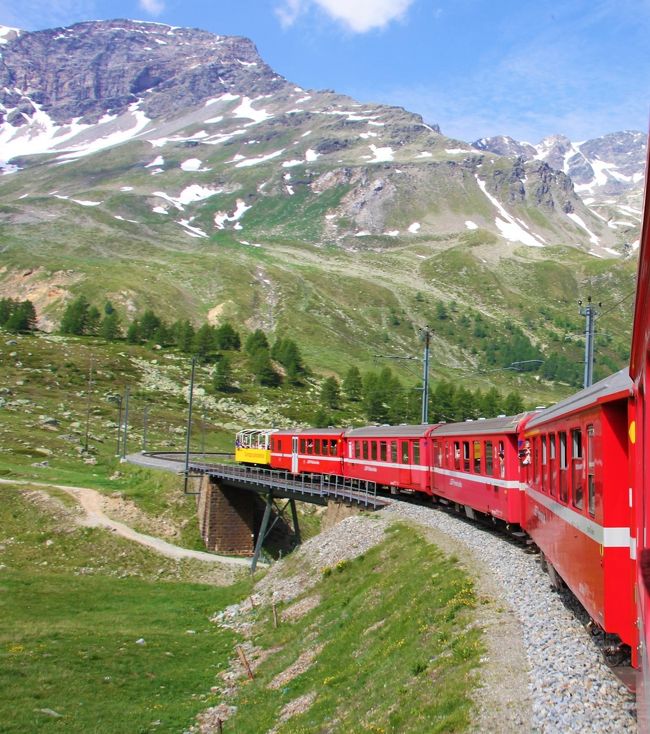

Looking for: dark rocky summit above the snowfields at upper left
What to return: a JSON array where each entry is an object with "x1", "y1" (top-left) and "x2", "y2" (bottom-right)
[{"x1": 0, "y1": 20, "x2": 287, "y2": 126}]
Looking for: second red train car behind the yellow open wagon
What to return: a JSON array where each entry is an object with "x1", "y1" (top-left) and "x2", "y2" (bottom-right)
[{"x1": 344, "y1": 425, "x2": 436, "y2": 494}]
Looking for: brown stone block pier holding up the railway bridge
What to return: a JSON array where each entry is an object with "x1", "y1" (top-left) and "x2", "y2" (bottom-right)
[{"x1": 197, "y1": 475, "x2": 258, "y2": 556}]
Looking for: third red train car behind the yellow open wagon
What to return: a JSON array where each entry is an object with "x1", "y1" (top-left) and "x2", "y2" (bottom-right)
[{"x1": 432, "y1": 413, "x2": 533, "y2": 525}]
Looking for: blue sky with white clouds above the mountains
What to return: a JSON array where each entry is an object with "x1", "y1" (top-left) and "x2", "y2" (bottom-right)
[{"x1": 0, "y1": 0, "x2": 650, "y2": 143}]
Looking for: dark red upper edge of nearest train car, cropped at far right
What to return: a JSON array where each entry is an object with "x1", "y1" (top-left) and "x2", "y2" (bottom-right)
[{"x1": 630, "y1": 135, "x2": 650, "y2": 381}]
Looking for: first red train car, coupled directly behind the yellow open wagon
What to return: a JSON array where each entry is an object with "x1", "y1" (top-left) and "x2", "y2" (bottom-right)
[{"x1": 271, "y1": 428, "x2": 344, "y2": 475}]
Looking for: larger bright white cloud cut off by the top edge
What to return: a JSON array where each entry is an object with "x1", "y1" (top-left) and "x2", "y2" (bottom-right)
[{"x1": 276, "y1": 0, "x2": 414, "y2": 33}]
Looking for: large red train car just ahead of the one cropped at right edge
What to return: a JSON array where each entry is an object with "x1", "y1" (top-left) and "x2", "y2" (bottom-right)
[{"x1": 524, "y1": 370, "x2": 637, "y2": 664}]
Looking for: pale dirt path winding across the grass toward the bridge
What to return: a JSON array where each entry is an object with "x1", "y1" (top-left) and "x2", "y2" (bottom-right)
[{"x1": 0, "y1": 479, "x2": 250, "y2": 566}]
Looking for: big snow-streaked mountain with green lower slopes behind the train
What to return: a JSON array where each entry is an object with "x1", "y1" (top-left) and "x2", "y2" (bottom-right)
[{"x1": 0, "y1": 20, "x2": 635, "y2": 392}]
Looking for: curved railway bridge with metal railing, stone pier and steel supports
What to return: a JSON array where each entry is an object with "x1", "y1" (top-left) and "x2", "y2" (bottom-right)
[{"x1": 126, "y1": 452, "x2": 390, "y2": 571}]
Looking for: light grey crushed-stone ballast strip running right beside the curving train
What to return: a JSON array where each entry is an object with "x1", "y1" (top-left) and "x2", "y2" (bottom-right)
[{"x1": 381, "y1": 502, "x2": 636, "y2": 734}]
